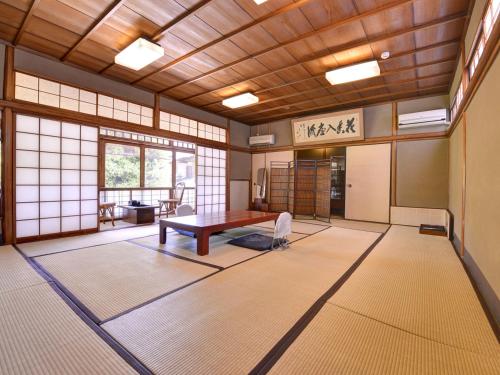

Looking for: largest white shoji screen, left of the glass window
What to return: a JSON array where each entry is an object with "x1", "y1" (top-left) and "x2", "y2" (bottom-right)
[{"x1": 15, "y1": 115, "x2": 98, "y2": 238}]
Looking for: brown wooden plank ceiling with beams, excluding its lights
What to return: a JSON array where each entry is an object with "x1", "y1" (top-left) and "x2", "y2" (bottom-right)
[{"x1": 0, "y1": 0, "x2": 469, "y2": 124}]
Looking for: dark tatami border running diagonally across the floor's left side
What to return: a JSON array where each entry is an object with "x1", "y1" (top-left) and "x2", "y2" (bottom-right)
[{"x1": 13, "y1": 245, "x2": 153, "y2": 375}]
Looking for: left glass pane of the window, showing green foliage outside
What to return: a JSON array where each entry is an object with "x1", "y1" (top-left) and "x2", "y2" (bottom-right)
[{"x1": 104, "y1": 143, "x2": 141, "y2": 188}]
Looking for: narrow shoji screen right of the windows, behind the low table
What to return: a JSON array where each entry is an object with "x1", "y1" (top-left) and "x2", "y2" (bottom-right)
[{"x1": 196, "y1": 146, "x2": 227, "y2": 214}]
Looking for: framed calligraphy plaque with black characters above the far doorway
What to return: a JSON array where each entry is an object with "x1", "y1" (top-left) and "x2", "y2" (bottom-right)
[{"x1": 292, "y1": 108, "x2": 364, "y2": 146}]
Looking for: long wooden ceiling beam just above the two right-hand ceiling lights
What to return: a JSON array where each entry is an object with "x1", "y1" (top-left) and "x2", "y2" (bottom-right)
[{"x1": 175, "y1": 12, "x2": 467, "y2": 101}]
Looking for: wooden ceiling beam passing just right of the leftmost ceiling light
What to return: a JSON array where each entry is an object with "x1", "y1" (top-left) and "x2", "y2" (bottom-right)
[{"x1": 132, "y1": 0, "x2": 311, "y2": 84}]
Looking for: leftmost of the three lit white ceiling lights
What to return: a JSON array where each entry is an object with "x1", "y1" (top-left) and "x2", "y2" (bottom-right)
[{"x1": 115, "y1": 38, "x2": 165, "y2": 70}]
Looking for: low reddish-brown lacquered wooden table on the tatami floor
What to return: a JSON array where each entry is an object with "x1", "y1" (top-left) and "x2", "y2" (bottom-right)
[{"x1": 160, "y1": 211, "x2": 280, "y2": 255}]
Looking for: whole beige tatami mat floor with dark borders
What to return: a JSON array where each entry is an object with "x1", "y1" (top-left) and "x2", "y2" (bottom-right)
[{"x1": 0, "y1": 221, "x2": 500, "y2": 374}]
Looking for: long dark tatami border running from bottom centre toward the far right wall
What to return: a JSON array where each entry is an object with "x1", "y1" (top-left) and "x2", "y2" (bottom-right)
[{"x1": 250, "y1": 225, "x2": 391, "y2": 375}]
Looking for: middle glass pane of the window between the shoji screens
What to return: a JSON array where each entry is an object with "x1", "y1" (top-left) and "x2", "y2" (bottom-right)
[{"x1": 144, "y1": 148, "x2": 172, "y2": 187}]
